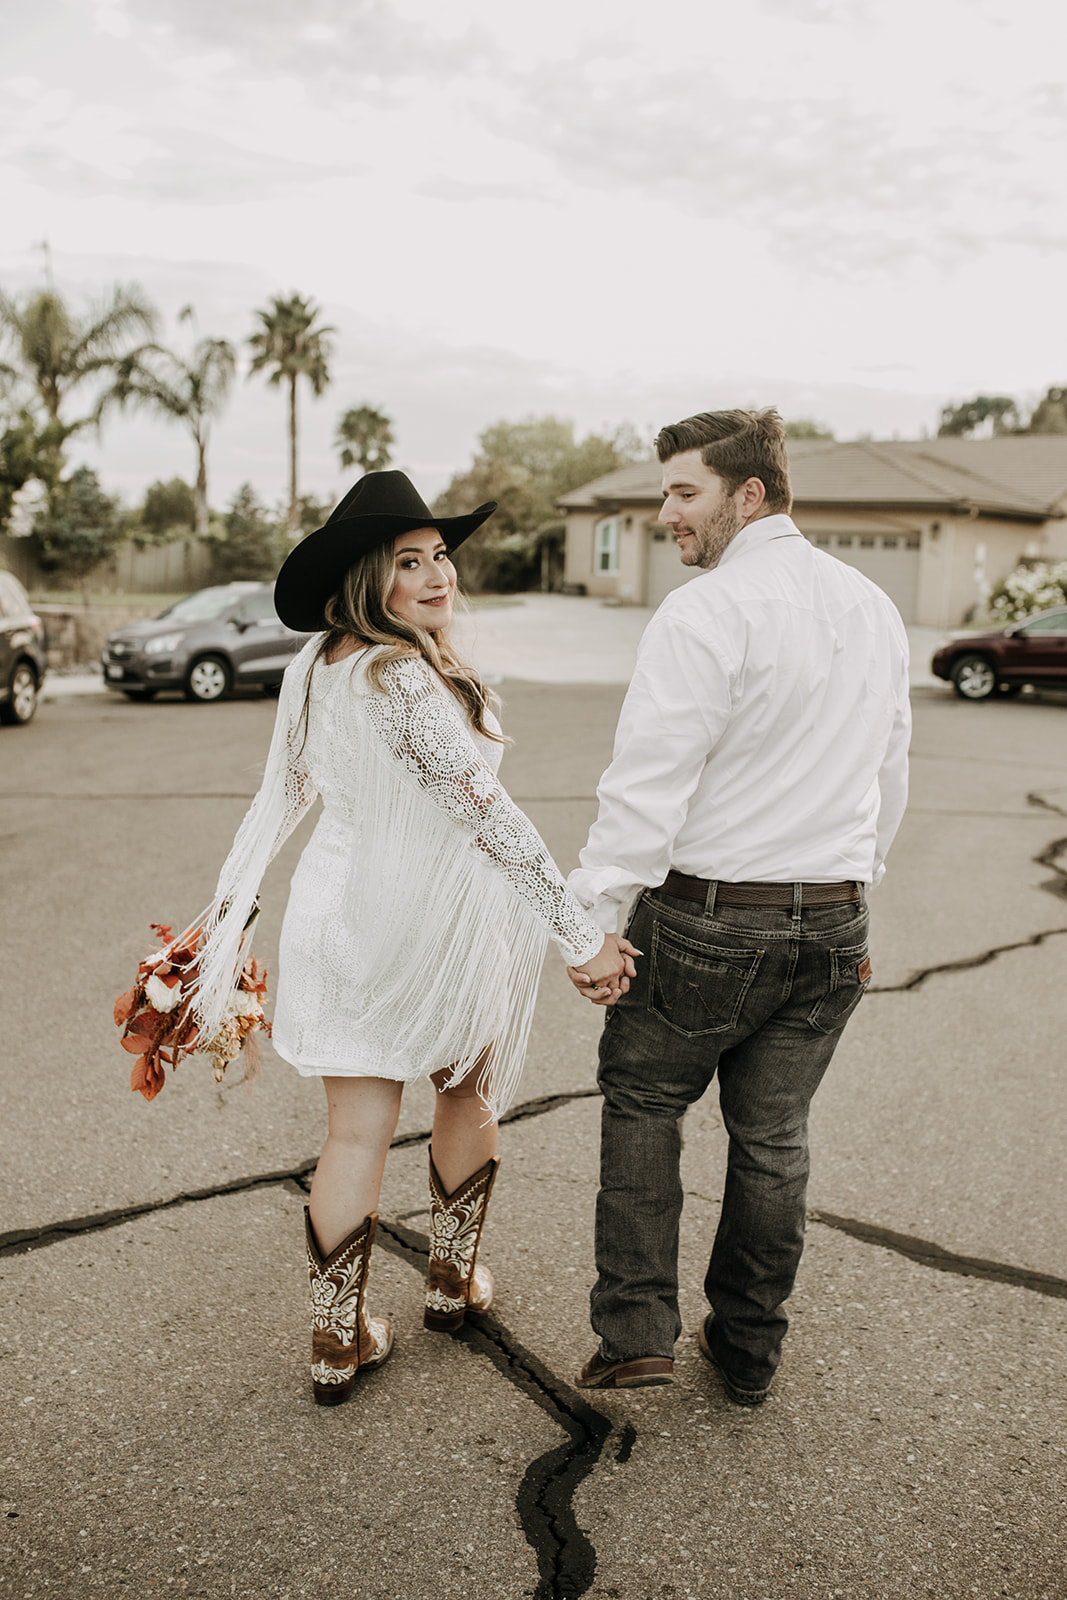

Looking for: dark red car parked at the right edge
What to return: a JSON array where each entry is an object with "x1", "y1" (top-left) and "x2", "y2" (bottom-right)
[{"x1": 929, "y1": 606, "x2": 1067, "y2": 699}]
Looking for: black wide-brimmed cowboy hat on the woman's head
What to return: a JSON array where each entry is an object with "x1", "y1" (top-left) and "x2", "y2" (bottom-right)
[{"x1": 274, "y1": 472, "x2": 496, "y2": 634}]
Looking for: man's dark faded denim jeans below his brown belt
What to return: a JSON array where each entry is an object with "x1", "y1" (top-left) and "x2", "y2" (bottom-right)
[{"x1": 590, "y1": 885, "x2": 870, "y2": 1389}]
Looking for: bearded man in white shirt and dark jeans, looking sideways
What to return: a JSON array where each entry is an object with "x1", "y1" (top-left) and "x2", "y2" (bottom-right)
[{"x1": 569, "y1": 411, "x2": 910, "y2": 1405}]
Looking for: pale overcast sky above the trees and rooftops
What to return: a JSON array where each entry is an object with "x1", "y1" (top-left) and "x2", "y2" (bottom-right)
[{"x1": 0, "y1": 0, "x2": 1067, "y2": 504}]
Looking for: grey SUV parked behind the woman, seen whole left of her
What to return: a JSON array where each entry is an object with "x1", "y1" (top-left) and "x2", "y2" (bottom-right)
[{"x1": 101, "y1": 584, "x2": 310, "y2": 701}]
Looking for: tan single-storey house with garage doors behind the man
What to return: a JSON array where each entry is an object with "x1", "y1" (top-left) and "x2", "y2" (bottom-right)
[{"x1": 557, "y1": 434, "x2": 1067, "y2": 627}]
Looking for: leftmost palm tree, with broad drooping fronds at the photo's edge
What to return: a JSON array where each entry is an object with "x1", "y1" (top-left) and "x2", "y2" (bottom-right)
[{"x1": 0, "y1": 283, "x2": 155, "y2": 482}]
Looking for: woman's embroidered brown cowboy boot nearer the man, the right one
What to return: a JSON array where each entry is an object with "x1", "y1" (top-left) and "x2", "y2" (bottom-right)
[{"x1": 422, "y1": 1152, "x2": 501, "y2": 1333}]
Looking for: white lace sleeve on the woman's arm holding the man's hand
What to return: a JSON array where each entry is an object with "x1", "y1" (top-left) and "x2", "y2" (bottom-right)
[{"x1": 366, "y1": 661, "x2": 603, "y2": 965}]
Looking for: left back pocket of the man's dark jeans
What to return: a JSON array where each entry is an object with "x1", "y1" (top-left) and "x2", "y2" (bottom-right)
[{"x1": 648, "y1": 923, "x2": 763, "y2": 1038}]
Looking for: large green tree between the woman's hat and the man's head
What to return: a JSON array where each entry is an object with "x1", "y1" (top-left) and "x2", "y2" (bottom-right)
[{"x1": 434, "y1": 416, "x2": 645, "y2": 589}]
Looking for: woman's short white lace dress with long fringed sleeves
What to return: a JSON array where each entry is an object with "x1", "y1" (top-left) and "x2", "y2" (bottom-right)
[{"x1": 200, "y1": 640, "x2": 603, "y2": 1115}]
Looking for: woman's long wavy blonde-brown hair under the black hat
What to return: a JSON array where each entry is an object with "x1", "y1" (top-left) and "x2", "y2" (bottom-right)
[{"x1": 295, "y1": 539, "x2": 510, "y2": 744}]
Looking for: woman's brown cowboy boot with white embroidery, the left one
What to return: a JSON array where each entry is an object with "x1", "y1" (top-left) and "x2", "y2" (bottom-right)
[{"x1": 304, "y1": 1206, "x2": 392, "y2": 1405}]
